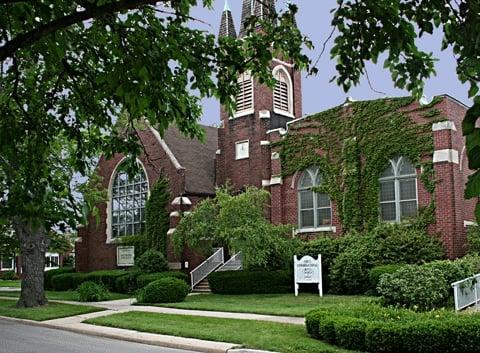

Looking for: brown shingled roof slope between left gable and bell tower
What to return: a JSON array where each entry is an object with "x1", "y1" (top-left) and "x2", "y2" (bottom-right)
[{"x1": 163, "y1": 126, "x2": 218, "y2": 195}]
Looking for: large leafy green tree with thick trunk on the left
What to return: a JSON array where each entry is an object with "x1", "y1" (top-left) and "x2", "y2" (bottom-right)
[{"x1": 0, "y1": 0, "x2": 310, "y2": 307}]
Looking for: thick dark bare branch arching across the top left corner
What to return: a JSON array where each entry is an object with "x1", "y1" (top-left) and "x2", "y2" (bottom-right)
[{"x1": 0, "y1": 0, "x2": 166, "y2": 62}]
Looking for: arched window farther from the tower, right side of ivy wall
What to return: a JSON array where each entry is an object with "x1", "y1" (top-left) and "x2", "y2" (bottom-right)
[{"x1": 379, "y1": 157, "x2": 418, "y2": 222}]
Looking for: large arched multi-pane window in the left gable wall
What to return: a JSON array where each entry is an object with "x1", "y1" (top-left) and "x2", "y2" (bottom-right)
[{"x1": 110, "y1": 162, "x2": 148, "y2": 238}]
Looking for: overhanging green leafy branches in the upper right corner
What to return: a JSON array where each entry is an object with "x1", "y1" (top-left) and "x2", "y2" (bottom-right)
[{"x1": 331, "y1": 0, "x2": 480, "y2": 217}]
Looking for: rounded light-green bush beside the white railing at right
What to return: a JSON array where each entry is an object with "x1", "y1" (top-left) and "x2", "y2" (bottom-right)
[{"x1": 377, "y1": 265, "x2": 449, "y2": 310}]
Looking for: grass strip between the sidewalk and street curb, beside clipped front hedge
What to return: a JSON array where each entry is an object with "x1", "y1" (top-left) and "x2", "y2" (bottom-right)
[{"x1": 85, "y1": 311, "x2": 353, "y2": 353}]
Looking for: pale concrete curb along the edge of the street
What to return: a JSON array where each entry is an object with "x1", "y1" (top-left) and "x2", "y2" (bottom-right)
[{"x1": 0, "y1": 316, "x2": 239, "y2": 353}]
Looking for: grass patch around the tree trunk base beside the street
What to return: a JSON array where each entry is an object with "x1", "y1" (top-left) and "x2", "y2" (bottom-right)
[{"x1": 0, "y1": 299, "x2": 103, "y2": 321}]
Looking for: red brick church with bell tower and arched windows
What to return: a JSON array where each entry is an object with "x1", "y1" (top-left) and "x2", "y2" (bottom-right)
[{"x1": 76, "y1": 0, "x2": 476, "y2": 271}]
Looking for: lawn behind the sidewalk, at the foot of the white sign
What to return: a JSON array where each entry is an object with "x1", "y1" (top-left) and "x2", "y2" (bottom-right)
[{"x1": 160, "y1": 293, "x2": 377, "y2": 317}]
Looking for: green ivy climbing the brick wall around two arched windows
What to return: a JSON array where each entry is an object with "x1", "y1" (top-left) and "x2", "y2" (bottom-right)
[{"x1": 275, "y1": 97, "x2": 445, "y2": 231}]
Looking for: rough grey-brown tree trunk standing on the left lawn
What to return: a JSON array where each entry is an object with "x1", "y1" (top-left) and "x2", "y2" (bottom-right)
[{"x1": 13, "y1": 219, "x2": 48, "y2": 308}]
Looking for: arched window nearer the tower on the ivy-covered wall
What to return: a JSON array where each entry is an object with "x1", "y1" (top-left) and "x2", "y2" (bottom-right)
[{"x1": 298, "y1": 167, "x2": 332, "y2": 229}]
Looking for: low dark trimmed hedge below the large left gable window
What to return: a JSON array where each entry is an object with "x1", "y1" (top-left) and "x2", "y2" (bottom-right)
[{"x1": 51, "y1": 270, "x2": 126, "y2": 291}]
